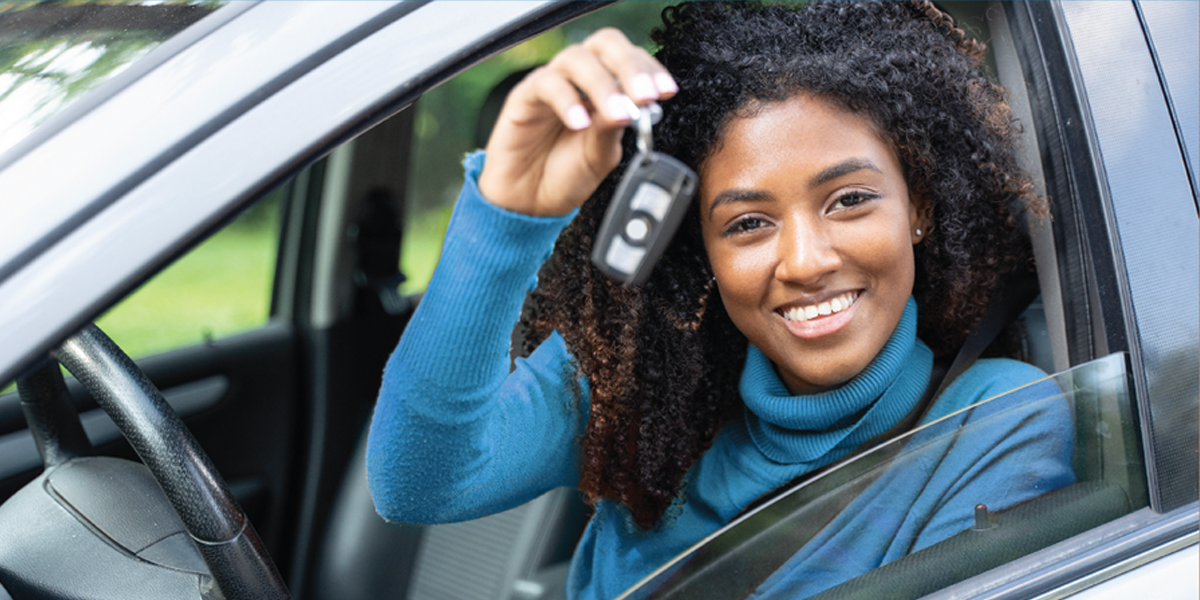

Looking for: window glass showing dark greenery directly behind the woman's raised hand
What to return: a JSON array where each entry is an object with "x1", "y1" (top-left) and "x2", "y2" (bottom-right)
[{"x1": 400, "y1": 1, "x2": 677, "y2": 294}]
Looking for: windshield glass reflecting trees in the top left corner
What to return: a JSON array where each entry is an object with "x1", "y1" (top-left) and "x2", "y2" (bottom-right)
[{"x1": 0, "y1": 0, "x2": 226, "y2": 152}]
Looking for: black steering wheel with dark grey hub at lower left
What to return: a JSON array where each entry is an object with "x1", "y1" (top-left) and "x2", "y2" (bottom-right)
[{"x1": 0, "y1": 324, "x2": 290, "y2": 600}]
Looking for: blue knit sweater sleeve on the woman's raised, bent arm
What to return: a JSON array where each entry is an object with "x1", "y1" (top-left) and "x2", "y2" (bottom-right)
[{"x1": 367, "y1": 152, "x2": 587, "y2": 523}]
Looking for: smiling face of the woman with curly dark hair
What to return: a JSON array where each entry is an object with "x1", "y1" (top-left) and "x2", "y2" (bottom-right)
[{"x1": 700, "y1": 95, "x2": 928, "y2": 394}]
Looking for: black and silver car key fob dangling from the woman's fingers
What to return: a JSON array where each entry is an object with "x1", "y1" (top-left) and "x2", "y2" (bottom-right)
[{"x1": 592, "y1": 101, "x2": 697, "y2": 284}]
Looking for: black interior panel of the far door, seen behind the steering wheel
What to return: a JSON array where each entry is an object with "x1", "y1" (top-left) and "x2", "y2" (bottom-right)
[{"x1": 0, "y1": 322, "x2": 300, "y2": 554}]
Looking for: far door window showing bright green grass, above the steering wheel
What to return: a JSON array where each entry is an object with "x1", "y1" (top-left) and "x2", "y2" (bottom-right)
[{"x1": 96, "y1": 186, "x2": 286, "y2": 359}]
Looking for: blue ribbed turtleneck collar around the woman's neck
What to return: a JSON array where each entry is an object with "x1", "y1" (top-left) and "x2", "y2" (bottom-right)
[{"x1": 739, "y1": 298, "x2": 934, "y2": 468}]
